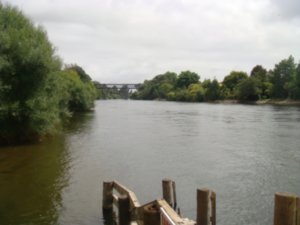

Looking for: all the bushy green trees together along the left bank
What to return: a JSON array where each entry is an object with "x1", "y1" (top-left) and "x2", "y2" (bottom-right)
[{"x1": 0, "y1": 2, "x2": 97, "y2": 144}]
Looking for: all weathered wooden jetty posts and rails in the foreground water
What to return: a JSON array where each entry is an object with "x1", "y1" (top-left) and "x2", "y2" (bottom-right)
[{"x1": 102, "y1": 179, "x2": 300, "y2": 225}]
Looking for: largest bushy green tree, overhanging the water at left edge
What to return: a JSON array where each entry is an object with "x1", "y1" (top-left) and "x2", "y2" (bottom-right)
[{"x1": 0, "y1": 3, "x2": 61, "y2": 143}]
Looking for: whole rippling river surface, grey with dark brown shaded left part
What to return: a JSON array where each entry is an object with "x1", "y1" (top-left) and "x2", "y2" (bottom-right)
[{"x1": 0, "y1": 101, "x2": 300, "y2": 225}]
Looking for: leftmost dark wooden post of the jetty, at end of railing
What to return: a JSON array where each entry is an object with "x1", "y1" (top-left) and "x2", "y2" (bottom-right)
[{"x1": 102, "y1": 182, "x2": 113, "y2": 216}]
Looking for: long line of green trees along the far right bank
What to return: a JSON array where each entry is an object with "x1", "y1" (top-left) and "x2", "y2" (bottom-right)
[{"x1": 131, "y1": 56, "x2": 300, "y2": 102}]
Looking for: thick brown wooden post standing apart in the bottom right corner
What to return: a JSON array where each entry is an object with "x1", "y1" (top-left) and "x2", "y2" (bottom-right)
[{"x1": 274, "y1": 192, "x2": 297, "y2": 225}]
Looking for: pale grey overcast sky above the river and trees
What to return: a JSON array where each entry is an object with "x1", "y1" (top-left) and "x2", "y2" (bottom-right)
[{"x1": 4, "y1": 0, "x2": 300, "y2": 83}]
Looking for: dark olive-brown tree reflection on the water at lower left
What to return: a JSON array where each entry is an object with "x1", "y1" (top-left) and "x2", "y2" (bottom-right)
[{"x1": 0, "y1": 137, "x2": 68, "y2": 224}]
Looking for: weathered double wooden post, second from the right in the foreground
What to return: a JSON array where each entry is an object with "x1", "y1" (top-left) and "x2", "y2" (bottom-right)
[{"x1": 197, "y1": 189, "x2": 216, "y2": 225}]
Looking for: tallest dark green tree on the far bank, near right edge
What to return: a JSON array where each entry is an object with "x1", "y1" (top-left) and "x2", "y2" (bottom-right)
[{"x1": 271, "y1": 56, "x2": 296, "y2": 99}]
